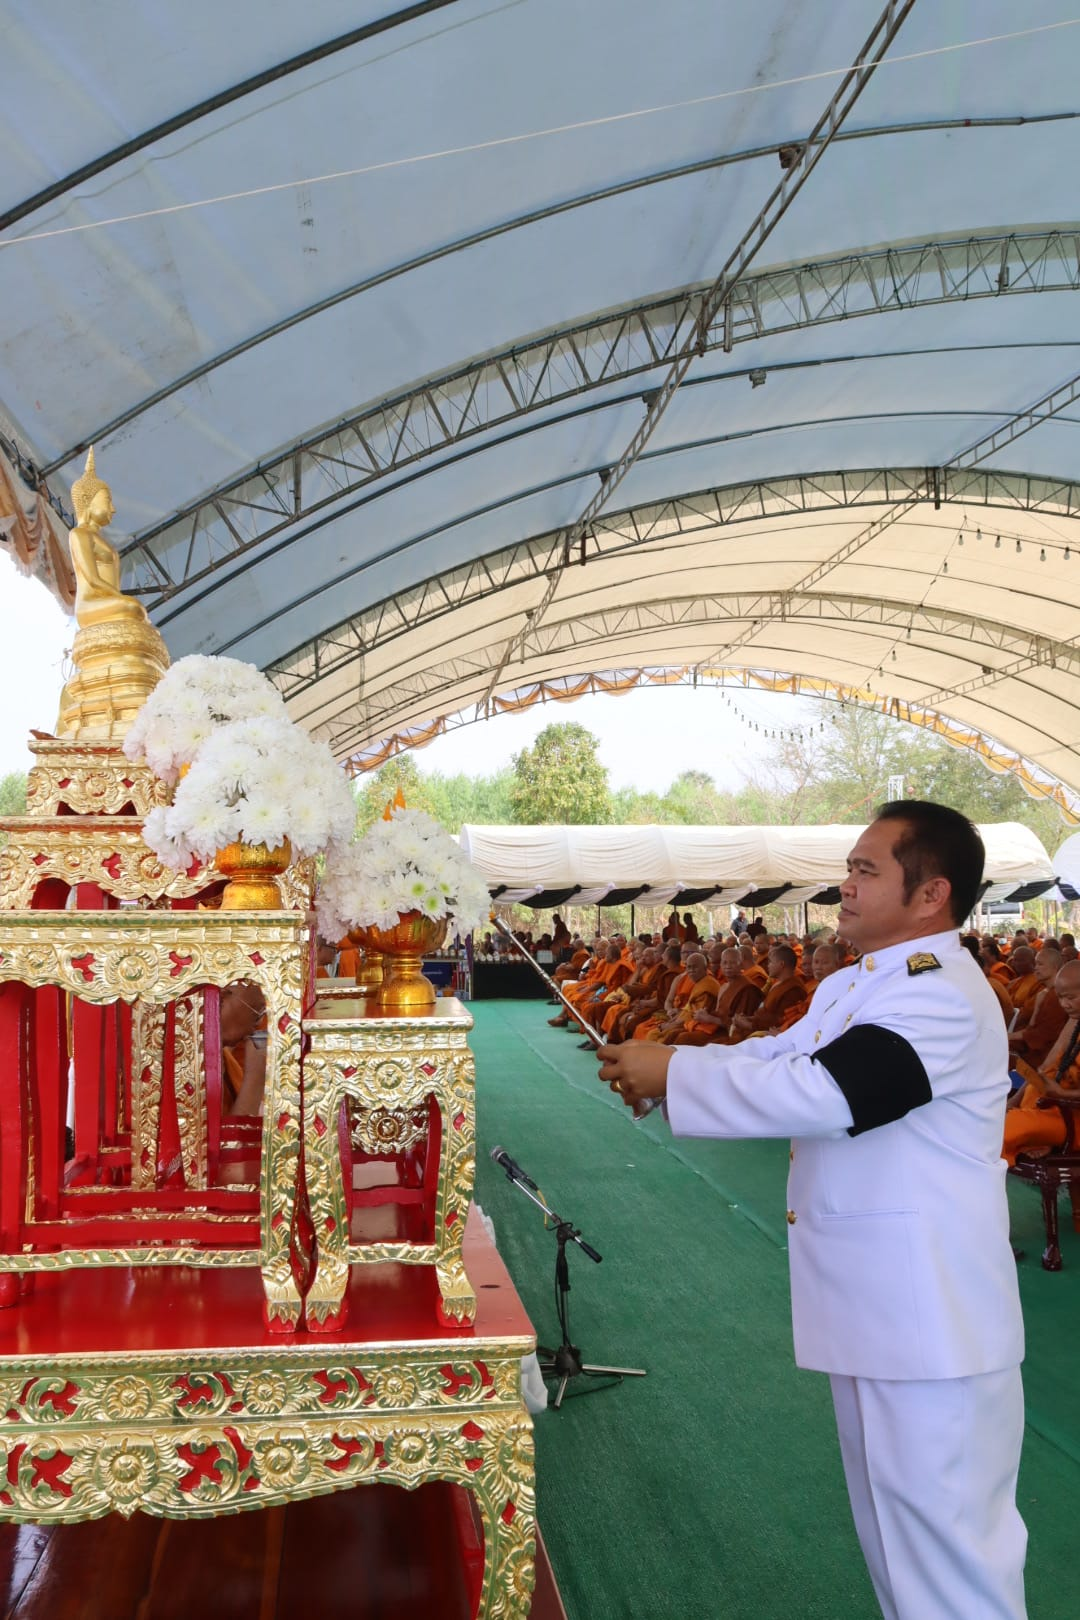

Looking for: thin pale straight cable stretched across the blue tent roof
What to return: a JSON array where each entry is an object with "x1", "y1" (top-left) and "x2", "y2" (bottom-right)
[{"x1": 0, "y1": 16, "x2": 1080, "y2": 248}]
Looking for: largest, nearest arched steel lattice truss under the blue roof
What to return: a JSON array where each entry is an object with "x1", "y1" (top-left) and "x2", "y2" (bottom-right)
[{"x1": 114, "y1": 218, "x2": 1080, "y2": 609}]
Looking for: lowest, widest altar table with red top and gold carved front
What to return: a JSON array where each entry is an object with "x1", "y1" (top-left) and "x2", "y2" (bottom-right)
[{"x1": 0, "y1": 1210, "x2": 536, "y2": 1620}]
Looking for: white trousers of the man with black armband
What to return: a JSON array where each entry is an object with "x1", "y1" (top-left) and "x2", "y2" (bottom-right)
[{"x1": 831, "y1": 1367, "x2": 1028, "y2": 1620}]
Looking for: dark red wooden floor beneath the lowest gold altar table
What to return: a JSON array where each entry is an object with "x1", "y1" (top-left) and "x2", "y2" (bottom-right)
[{"x1": 0, "y1": 1484, "x2": 565, "y2": 1620}]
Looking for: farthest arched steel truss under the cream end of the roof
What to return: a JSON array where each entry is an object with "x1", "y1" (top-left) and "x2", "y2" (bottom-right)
[{"x1": 316, "y1": 591, "x2": 1080, "y2": 755}]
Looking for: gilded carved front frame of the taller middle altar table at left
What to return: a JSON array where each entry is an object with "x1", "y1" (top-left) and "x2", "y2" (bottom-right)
[{"x1": 0, "y1": 910, "x2": 308, "y2": 1327}]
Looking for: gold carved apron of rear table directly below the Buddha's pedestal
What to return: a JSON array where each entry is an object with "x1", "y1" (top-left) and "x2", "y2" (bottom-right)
[{"x1": 0, "y1": 816, "x2": 217, "y2": 910}]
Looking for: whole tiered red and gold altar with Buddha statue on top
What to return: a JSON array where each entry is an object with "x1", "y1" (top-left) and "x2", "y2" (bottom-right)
[{"x1": 0, "y1": 463, "x2": 534, "y2": 1617}]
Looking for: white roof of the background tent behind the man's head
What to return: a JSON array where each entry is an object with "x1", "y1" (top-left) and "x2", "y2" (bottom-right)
[{"x1": 460, "y1": 821, "x2": 1054, "y2": 902}]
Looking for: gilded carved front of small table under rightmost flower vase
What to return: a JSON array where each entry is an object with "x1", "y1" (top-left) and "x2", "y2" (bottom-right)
[{"x1": 304, "y1": 1001, "x2": 476, "y2": 1325}]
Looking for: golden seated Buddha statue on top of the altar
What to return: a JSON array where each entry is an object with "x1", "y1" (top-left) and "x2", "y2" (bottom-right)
[{"x1": 57, "y1": 446, "x2": 168, "y2": 742}]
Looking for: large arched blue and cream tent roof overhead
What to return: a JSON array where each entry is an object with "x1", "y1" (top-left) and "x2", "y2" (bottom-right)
[{"x1": 0, "y1": 0, "x2": 1080, "y2": 803}]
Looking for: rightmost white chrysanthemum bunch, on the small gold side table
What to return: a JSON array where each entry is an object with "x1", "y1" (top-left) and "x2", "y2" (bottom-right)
[{"x1": 316, "y1": 810, "x2": 491, "y2": 940}]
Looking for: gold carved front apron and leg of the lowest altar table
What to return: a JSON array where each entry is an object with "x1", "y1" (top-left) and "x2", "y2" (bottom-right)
[{"x1": 0, "y1": 1337, "x2": 536, "y2": 1620}]
